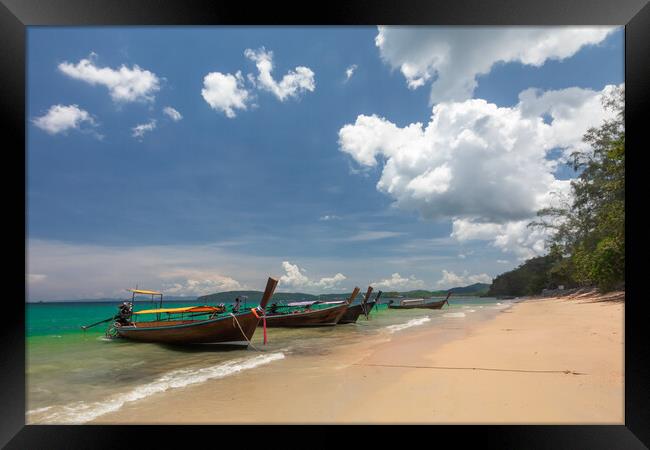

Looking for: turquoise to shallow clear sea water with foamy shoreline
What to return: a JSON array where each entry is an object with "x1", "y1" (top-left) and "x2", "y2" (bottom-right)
[{"x1": 26, "y1": 297, "x2": 512, "y2": 423}]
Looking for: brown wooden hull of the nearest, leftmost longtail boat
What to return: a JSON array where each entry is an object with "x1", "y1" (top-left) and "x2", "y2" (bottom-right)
[{"x1": 117, "y1": 312, "x2": 259, "y2": 346}]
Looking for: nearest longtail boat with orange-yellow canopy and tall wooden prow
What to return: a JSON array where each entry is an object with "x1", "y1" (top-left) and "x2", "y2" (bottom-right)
[{"x1": 84, "y1": 278, "x2": 278, "y2": 346}]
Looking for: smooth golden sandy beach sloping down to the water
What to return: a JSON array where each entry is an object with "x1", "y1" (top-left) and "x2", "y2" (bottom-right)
[{"x1": 93, "y1": 295, "x2": 624, "y2": 424}]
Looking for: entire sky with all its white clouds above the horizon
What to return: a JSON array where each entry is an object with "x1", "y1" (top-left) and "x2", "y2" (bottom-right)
[{"x1": 26, "y1": 27, "x2": 624, "y2": 301}]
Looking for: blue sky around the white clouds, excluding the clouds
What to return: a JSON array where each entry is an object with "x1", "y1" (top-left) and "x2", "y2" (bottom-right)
[{"x1": 26, "y1": 27, "x2": 624, "y2": 299}]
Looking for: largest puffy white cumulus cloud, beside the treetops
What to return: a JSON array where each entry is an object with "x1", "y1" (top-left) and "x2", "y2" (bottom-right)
[{"x1": 339, "y1": 86, "x2": 615, "y2": 257}]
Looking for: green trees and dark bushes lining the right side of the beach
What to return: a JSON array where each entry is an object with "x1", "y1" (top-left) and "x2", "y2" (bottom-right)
[{"x1": 490, "y1": 87, "x2": 625, "y2": 295}]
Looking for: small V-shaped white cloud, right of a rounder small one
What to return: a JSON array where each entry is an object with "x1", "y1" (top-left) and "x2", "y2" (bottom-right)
[{"x1": 244, "y1": 47, "x2": 316, "y2": 101}]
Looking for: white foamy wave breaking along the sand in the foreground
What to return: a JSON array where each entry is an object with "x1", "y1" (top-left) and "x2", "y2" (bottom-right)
[{"x1": 27, "y1": 352, "x2": 284, "y2": 424}]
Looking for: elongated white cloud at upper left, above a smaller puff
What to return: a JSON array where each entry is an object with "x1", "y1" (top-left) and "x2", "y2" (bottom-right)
[{"x1": 58, "y1": 54, "x2": 160, "y2": 102}]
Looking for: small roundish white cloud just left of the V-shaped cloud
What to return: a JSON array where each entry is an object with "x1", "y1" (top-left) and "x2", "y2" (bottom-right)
[{"x1": 201, "y1": 71, "x2": 250, "y2": 119}]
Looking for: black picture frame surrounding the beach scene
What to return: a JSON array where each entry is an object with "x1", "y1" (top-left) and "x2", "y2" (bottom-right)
[{"x1": 0, "y1": 0, "x2": 650, "y2": 449}]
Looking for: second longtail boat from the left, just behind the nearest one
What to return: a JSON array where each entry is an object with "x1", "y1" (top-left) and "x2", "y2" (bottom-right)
[{"x1": 260, "y1": 287, "x2": 359, "y2": 328}]
